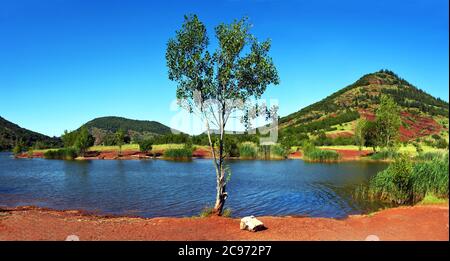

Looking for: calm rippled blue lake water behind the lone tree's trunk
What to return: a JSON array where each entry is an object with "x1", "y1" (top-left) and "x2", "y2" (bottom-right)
[{"x1": 0, "y1": 153, "x2": 386, "y2": 218}]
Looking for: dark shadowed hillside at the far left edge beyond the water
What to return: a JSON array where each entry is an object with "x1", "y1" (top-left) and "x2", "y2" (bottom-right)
[{"x1": 0, "y1": 117, "x2": 62, "y2": 151}]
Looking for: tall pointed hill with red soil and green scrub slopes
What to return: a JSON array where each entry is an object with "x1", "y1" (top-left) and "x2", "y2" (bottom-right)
[{"x1": 279, "y1": 70, "x2": 449, "y2": 145}]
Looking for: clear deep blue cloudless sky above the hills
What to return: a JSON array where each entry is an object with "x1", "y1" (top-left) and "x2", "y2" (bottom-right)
[{"x1": 0, "y1": 0, "x2": 449, "y2": 136}]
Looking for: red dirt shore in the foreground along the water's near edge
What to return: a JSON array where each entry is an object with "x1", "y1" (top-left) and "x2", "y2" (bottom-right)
[{"x1": 0, "y1": 204, "x2": 449, "y2": 241}]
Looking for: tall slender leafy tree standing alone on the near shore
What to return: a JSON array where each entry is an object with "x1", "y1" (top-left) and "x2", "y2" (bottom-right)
[{"x1": 166, "y1": 15, "x2": 279, "y2": 215}]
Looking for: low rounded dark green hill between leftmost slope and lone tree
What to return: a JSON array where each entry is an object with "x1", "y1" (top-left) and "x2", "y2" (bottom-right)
[{"x1": 83, "y1": 116, "x2": 172, "y2": 145}]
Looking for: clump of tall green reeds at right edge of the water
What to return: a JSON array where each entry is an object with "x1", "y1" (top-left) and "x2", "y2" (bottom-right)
[{"x1": 367, "y1": 154, "x2": 449, "y2": 204}]
